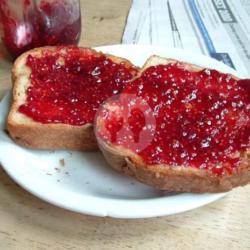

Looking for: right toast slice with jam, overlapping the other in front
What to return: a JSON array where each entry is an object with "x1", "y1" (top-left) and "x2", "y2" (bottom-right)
[{"x1": 95, "y1": 56, "x2": 250, "y2": 193}]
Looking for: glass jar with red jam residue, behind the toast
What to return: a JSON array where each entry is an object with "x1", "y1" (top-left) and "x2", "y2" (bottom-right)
[{"x1": 0, "y1": 0, "x2": 81, "y2": 58}]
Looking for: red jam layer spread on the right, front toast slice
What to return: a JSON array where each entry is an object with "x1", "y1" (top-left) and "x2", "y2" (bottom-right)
[{"x1": 99, "y1": 64, "x2": 250, "y2": 175}]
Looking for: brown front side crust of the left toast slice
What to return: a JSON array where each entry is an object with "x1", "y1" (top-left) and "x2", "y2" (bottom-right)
[{"x1": 7, "y1": 121, "x2": 97, "y2": 150}]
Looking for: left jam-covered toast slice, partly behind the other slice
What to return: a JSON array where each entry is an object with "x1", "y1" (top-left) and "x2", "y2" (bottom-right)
[{"x1": 7, "y1": 46, "x2": 138, "y2": 150}]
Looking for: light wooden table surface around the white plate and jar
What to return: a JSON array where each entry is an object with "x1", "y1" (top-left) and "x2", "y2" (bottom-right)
[{"x1": 0, "y1": 0, "x2": 250, "y2": 250}]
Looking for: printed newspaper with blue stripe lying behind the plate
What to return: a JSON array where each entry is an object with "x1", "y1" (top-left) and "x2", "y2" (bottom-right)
[{"x1": 122, "y1": 0, "x2": 250, "y2": 77}]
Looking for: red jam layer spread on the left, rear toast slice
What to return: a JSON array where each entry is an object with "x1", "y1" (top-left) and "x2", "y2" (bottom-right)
[{"x1": 19, "y1": 46, "x2": 137, "y2": 125}]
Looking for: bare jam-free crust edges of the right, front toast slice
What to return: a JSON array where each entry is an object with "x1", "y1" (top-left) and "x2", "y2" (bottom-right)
[{"x1": 95, "y1": 56, "x2": 250, "y2": 193}]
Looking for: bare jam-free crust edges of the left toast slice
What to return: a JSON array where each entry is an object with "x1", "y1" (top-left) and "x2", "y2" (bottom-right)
[{"x1": 7, "y1": 46, "x2": 138, "y2": 150}]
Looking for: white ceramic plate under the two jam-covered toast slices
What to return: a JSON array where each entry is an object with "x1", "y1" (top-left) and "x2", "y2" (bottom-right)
[{"x1": 0, "y1": 45, "x2": 238, "y2": 218}]
